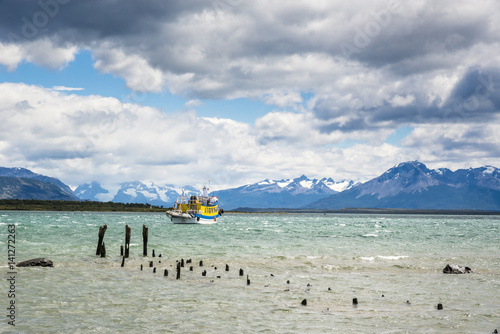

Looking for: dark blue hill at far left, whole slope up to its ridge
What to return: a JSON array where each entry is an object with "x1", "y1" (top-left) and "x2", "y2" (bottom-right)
[{"x1": 0, "y1": 167, "x2": 79, "y2": 201}]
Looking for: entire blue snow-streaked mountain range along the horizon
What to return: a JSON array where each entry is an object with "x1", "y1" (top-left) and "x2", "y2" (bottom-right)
[{"x1": 0, "y1": 161, "x2": 500, "y2": 211}]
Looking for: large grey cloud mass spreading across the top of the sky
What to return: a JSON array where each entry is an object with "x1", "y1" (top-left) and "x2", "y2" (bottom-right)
[{"x1": 0, "y1": 0, "x2": 500, "y2": 132}]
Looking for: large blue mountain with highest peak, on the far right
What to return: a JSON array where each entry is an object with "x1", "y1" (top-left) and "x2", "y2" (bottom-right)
[{"x1": 306, "y1": 161, "x2": 500, "y2": 210}]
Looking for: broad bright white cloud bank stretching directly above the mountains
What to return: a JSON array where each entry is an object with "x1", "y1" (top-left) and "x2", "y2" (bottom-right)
[{"x1": 0, "y1": 83, "x2": 500, "y2": 189}]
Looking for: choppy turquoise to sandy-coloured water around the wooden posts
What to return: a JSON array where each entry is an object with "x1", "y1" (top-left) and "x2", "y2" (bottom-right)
[{"x1": 0, "y1": 211, "x2": 500, "y2": 333}]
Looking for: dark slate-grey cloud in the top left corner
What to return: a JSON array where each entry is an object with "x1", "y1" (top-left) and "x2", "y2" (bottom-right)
[{"x1": 0, "y1": 0, "x2": 207, "y2": 43}]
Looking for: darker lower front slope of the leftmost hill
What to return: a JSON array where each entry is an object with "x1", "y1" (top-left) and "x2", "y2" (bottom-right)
[{"x1": 0, "y1": 176, "x2": 75, "y2": 201}]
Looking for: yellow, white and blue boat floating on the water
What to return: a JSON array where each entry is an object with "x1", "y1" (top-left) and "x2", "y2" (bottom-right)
[{"x1": 167, "y1": 187, "x2": 224, "y2": 224}]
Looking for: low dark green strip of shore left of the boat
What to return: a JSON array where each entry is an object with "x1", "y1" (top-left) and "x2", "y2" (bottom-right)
[{"x1": 0, "y1": 199, "x2": 168, "y2": 212}]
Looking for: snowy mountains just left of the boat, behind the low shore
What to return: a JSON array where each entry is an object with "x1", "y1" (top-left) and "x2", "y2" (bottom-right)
[{"x1": 113, "y1": 181, "x2": 201, "y2": 207}]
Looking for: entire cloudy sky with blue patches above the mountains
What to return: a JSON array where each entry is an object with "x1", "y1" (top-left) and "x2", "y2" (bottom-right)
[{"x1": 0, "y1": 0, "x2": 500, "y2": 190}]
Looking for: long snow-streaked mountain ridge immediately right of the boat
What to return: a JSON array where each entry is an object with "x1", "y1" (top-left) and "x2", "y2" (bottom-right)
[{"x1": 212, "y1": 175, "x2": 354, "y2": 210}]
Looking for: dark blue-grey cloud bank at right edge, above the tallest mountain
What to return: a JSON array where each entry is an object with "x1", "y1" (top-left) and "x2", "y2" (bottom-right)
[{"x1": 313, "y1": 67, "x2": 500, "y2": 132}]
